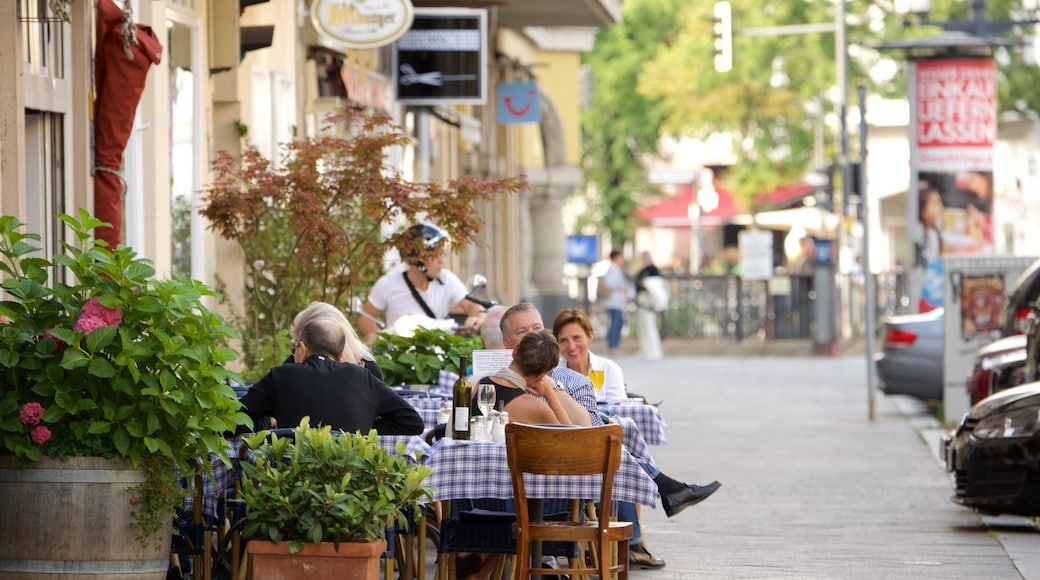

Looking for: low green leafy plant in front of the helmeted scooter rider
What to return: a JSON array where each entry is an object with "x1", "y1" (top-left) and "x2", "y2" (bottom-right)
[{"x1": 372, "y1": 326, "x2": 483, "y2": 386}]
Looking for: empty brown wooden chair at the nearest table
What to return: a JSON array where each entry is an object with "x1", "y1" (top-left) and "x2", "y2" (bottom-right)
[{"x1": 505, "y1": 423, "x2": 632, "y2": 580}]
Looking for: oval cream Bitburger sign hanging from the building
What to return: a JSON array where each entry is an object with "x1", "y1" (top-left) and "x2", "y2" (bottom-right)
[{"x1": 311, "y1": 0, "x2": 414, "y2": 49}]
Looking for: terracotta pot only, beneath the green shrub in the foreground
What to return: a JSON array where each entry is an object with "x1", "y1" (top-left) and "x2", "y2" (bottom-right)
[{"x1": 245, "y1": 539, "x2": 387, "y2": 580}]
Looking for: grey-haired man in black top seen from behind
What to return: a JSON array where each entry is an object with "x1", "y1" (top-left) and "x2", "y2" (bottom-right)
[{"x1": 241, "y1": 318, "x2": 424, "y2": 436}]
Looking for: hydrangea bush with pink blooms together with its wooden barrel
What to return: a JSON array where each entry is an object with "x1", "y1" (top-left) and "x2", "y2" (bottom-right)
[{"x1": 0, "y1": 210, "x2": 249, "y2": 578}]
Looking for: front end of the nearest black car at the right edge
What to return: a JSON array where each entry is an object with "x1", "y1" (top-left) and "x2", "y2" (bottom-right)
[{"x1": 942, "y1": 383, "x2": 1040, "y2": 516}]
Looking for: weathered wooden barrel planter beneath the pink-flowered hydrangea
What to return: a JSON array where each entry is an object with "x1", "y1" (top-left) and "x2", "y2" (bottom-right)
[{"x1": 0, "y1": 455, "x2": 173, "y2": 580}]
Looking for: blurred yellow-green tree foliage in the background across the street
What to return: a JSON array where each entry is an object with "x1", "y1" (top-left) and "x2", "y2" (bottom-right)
[{"x1": 583, "y1": 0, "x2": 1040, "y2": 229}]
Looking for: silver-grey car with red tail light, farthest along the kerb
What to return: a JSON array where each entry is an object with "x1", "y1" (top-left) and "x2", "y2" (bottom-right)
[{"x1": 875, "y1": 308, "x2": 943, "y2": 400}]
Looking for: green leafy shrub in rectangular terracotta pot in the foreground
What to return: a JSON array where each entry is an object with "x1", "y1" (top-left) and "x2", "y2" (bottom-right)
[{"x1": 242, "y1": 417, "x2": 433, "y2": 580}]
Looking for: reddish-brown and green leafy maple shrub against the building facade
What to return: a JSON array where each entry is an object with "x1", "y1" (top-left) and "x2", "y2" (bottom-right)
[{"x1": 201, "y1": 109, "x2": 525, "y2": 378}]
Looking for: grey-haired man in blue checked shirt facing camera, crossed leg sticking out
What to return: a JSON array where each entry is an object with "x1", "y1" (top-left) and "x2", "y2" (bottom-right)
[{"x1": 490, "y1": 302, "x2": 719, "y2": 569}]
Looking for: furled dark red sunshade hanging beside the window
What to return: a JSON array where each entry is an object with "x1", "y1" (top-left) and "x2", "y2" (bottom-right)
[{"x1": 94, "y1": 0, "x2": 162, "y2": 248}]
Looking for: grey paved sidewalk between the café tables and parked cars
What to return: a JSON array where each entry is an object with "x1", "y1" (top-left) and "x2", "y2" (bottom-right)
[{"x1": 618, "y1": 354, "x2": 1040, "y2": 580}]
